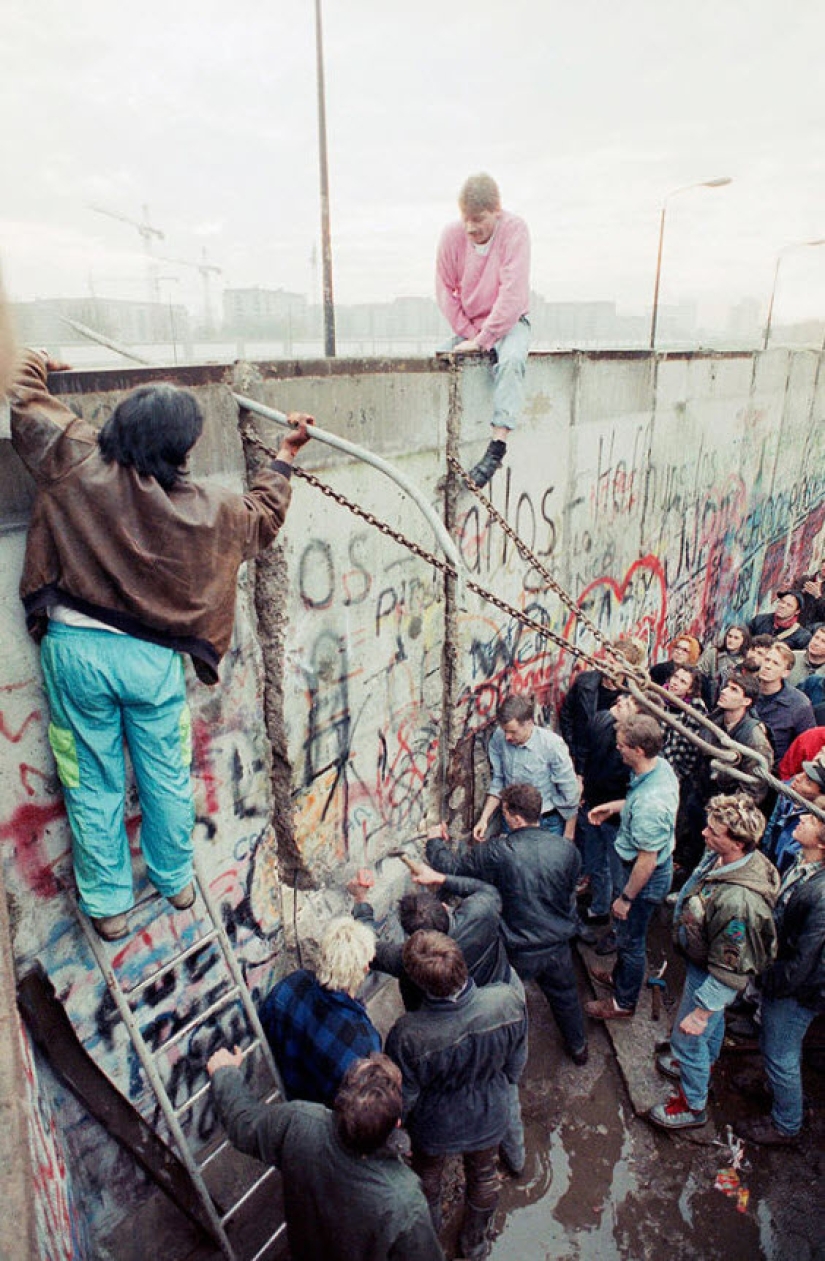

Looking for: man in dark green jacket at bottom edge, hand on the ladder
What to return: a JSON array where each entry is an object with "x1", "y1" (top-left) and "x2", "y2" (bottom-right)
[{"x1": 207, "y1": 1048, "x2": 444, "y2": 1261}]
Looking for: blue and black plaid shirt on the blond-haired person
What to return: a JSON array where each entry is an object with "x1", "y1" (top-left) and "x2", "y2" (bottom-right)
[{"x1": 259, "y1": 968, "x2": 381, "y2": 1107}]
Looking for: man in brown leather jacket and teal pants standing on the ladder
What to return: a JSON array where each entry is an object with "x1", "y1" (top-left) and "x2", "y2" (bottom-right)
[{"x1": 10, "y1": 351, "x2": 313, "y2": 941}]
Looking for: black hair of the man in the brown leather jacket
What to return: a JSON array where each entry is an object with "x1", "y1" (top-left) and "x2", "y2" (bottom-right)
[{"x1": 97, "y1": 381, "x2": 203, "y2": 491}]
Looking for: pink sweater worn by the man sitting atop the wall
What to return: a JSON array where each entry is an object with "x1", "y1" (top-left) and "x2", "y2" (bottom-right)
[{"x1": 435, "y1": 211, "x2": 530, "y2": 351}]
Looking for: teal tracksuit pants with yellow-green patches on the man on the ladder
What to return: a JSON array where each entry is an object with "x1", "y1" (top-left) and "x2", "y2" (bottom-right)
[{"x1": 40, "y1": 622, "x2": 194, "y2": 919}]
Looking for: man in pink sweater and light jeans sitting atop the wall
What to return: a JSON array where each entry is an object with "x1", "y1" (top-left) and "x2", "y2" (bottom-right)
[{"x1": 435, "y1": 175, "x2": 530, "y2": 487}]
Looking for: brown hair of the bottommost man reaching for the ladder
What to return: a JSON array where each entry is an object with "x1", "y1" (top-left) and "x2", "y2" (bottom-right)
[{"x1": 332, "y1": 1052, "x2": 401, "y2": 1155}]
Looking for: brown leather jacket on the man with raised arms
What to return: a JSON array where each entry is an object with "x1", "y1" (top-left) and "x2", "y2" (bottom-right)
[{"x1": 9, "y1": 351, "x2": 291, "y2": 683}]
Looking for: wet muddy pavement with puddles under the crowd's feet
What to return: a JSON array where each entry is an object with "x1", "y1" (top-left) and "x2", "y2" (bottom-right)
[{"x1": 102, "y1": 924, "x2": 825, "y2": 1261}]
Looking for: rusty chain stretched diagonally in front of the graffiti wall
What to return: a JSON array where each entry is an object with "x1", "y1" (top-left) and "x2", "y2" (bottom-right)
[{"x1": 240, "y1": 421, "x2": 825, "y2": 821}]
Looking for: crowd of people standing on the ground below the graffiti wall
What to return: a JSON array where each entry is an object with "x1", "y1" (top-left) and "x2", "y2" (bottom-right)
[{"x1": 209, "y1": 622, "x2": 825, "y2": 1258}]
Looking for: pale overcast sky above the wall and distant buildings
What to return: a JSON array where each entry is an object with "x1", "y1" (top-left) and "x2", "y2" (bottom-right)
[{"x1": 0, "y1": 0, "x2": 825, "y2": 322}]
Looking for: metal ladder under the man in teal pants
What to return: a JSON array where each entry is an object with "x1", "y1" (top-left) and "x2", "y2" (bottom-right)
[{"x1": 72, "y1": 865, "x2": 286, "y2": 1261}]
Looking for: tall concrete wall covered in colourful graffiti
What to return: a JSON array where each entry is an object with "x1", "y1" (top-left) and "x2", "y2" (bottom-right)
[{"x1": 0, "y1": 351, "x2": 825, "y2": 1240}]
